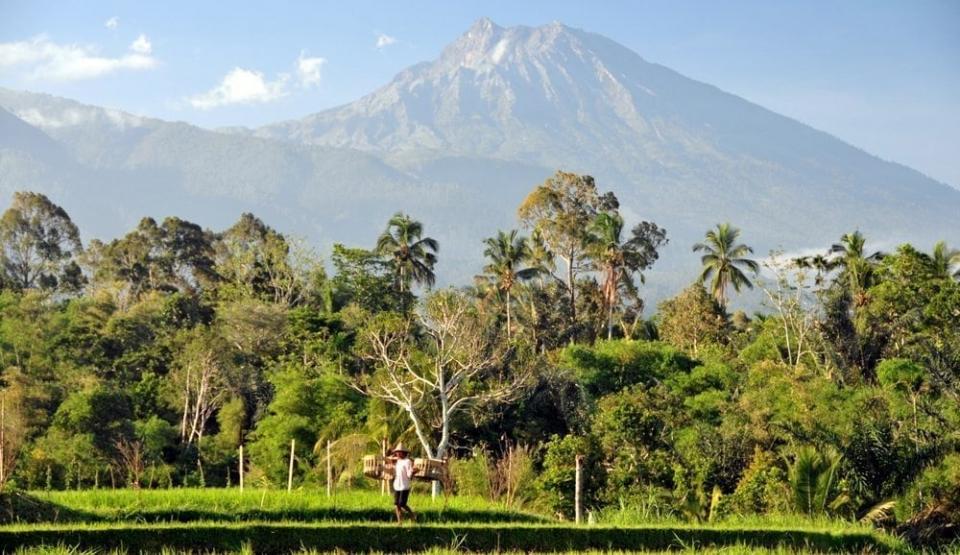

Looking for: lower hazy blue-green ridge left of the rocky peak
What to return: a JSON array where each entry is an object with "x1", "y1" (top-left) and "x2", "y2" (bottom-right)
[{"x1": 0, "y1": 89, "x2": 460, "y2": 245}]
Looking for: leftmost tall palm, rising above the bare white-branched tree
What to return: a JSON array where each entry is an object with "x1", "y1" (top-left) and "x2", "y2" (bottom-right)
[{"x1": 376, "y1": 212, "x2": 440, "y2": 293}]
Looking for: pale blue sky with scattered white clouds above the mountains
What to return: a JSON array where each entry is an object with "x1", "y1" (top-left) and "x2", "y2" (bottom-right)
[{"x1": 0, "y1": 0, "x2": 960, "y2": 186}]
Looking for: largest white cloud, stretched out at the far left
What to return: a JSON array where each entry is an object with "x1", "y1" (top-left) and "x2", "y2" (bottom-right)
[{"x1": 0, "y1": 35, "x2": 157, "y2": 81}]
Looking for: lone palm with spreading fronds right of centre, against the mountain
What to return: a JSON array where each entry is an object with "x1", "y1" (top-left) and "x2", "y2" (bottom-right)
[{"x1": 693, "y1": 223, "x2": 760, "y2": 309}]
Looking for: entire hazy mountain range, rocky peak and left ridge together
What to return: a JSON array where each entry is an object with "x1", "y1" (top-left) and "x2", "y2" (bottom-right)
[{"x1": 0, "y1": 19, "x2": 960, "y2": 304}]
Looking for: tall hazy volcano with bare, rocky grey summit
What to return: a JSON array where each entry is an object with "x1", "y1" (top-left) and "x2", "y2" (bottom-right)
[{"x1": 257, "y1": 19, "x2": 960, "y2": 253}]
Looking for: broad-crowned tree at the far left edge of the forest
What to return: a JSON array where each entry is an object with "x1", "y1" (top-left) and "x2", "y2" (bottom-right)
[{"x1": 0, "y1": 192, "x2": 83, "y2": 289}]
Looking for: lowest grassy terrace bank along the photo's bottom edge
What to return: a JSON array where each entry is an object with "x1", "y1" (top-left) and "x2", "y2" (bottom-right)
[{"x1": 0, "y1": 522, "x2": 902, "y2": 553}]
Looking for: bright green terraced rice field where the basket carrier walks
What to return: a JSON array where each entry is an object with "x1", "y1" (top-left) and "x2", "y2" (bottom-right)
[{"x1": 0, "y1": 489, "x2": 910, "y2": 554}]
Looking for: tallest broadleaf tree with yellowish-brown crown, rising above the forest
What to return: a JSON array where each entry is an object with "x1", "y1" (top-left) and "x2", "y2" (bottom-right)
[{"x1": 517, "y1": 171, "x2": 619, "y2": 322}]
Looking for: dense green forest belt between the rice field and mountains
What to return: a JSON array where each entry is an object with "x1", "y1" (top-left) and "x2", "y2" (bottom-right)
[{"x1": 0, "y1": 172, "x2": 960, "y2": 548}]
